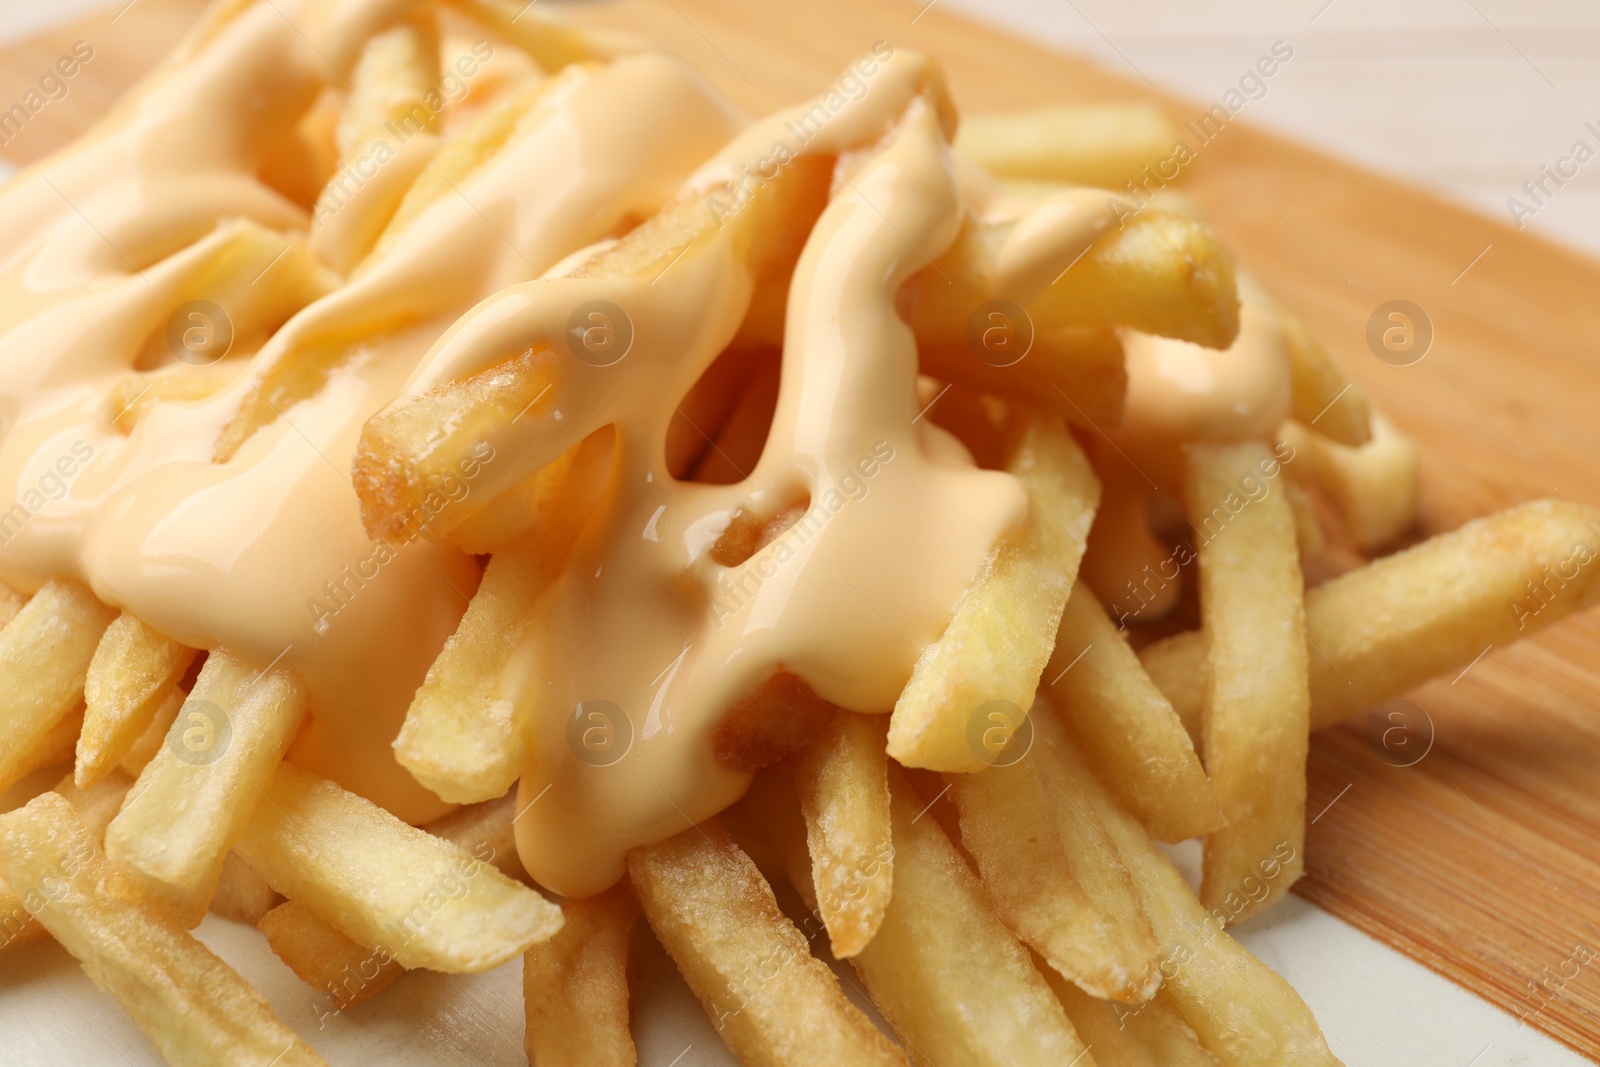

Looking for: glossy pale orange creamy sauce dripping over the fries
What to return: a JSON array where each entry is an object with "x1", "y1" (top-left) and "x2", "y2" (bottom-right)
[{"x1": 0, "y1": 0, "x2": 1286, "y2": 894}]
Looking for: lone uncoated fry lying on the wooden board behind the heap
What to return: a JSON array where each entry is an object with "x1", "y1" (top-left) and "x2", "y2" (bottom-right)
[{"x1": 955, "y1": 101, "x2": 1178, "y2": 187}]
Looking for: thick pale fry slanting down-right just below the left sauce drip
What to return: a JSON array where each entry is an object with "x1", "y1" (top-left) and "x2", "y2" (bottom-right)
[{"x1": 235, "y1": 763, "x2": 562, "y2": 974}]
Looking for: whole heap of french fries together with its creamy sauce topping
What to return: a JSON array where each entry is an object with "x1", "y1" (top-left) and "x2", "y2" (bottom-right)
[{"x1": 9, "y1": 0, "x2": 1600, "y2": 1067}]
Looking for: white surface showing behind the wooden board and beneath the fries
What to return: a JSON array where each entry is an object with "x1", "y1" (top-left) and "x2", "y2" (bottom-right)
[{"x1": 0, "y1": 0, "x2": 1600, "y2": 1067}]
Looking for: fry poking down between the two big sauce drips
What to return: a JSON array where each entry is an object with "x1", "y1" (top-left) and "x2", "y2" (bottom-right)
[{"x1": 395, "y1": 434, "x2": 611, "y2": 803}]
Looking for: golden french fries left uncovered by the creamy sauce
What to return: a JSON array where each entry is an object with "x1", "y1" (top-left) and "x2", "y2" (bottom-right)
[{"x1": 0, "y1": 0, "x2": 1600, "y2": 1067}]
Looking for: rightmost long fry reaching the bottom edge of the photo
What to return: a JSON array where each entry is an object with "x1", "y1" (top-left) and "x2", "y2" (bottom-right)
[{"x1": 1038, "y1": 721, "x2": 1339, "y2": 1067}]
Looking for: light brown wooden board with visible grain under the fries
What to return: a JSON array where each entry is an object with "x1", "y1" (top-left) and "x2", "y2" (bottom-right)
[{"x1": 9, "y1": 0, "x2": 1600, "y2": 1057}]
